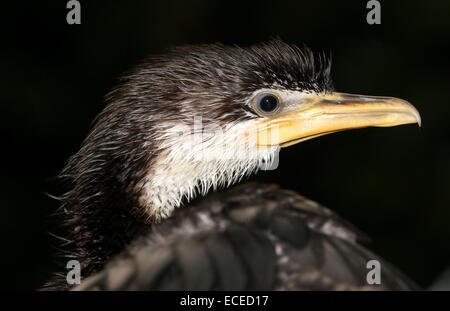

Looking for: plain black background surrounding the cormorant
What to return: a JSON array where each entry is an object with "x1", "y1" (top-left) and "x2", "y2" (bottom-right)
[{"x1": 0, "y1": 0, "x2": 450, "y2": 289}]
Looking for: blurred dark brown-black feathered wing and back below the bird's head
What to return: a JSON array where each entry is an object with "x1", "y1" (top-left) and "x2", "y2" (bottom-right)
[{"x1": 71, "y1": 184, "x2": 417, "y2": 290}]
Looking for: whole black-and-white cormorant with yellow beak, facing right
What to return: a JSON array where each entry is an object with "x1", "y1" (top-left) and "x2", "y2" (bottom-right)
[{"x1": 46, "y1": 40, "x2": 420, "y2": 290}]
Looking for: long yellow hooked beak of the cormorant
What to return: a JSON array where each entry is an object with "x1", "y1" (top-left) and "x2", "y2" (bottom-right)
[{"x1": 257, "y1": 93, "x2": 421, "y2": 147}]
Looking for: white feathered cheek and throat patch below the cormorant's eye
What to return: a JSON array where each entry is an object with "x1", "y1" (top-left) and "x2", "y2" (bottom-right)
[{"x1": 138, "y1": 120, "x2": 279, "y2": 221}]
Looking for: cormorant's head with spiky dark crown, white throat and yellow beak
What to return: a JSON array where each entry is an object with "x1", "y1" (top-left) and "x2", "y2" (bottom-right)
[{"x1": 63, "y1": 40, "x2": 420, "y2": 221}]
